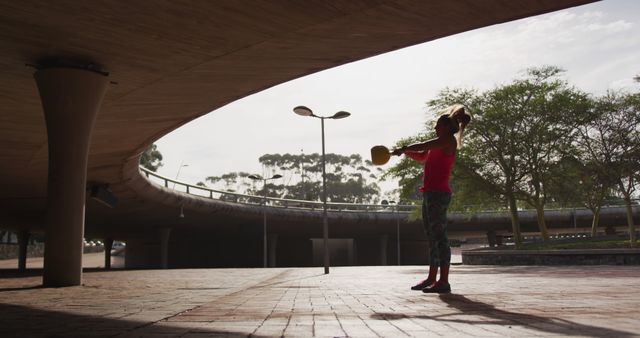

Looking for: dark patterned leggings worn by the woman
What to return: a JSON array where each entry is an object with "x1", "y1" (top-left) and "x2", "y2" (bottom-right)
[{"x1": 422, "y1": 191, "x2": 451, "y2": 265}]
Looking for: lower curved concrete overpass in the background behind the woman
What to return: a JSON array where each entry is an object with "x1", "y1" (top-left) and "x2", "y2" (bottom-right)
[{"x1": 126, "y1": 168, "x2": 640, "y2": 267}]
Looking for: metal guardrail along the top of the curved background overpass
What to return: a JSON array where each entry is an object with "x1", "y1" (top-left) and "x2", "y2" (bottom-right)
[{"x1": 139, "y1": 167, "x2": 640, "y2": 214}]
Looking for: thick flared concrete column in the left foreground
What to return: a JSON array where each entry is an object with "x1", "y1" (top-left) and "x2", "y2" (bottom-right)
[{"x1": 35, "y1": 67, "x2": 108, "y2": 286}]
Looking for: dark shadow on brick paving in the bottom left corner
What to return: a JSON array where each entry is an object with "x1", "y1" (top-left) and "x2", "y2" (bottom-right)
[{"x1": 0, "y1": 304, "x2": 259, "y2": 337}]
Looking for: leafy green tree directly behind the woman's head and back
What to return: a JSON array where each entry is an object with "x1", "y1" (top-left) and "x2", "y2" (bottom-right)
[{"x1": 387, "y1": 88, "x2": 525, "y2": 247}]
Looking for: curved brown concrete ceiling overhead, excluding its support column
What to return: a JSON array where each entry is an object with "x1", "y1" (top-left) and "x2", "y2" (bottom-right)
[{"x1": 0, "y1": 0, "x2": 593, "y2": 234}]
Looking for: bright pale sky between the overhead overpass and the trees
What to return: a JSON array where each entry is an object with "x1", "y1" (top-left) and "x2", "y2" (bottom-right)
[{"x1": 156, "y1": 0, "x2": 640, "y2": 197}]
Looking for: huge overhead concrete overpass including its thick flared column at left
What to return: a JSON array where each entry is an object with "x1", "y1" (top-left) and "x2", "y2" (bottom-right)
[{"x1": 0, "y1": 0, "x2": 592, "y2": 286}]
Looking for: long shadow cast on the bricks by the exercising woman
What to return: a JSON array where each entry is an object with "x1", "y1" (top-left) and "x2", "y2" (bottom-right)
[{"x1": 371, "y1": 294, "x2": 637, "y2": 337}]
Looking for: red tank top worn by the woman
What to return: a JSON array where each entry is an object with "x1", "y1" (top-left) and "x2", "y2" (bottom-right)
[{"x1": 420, "y1": 148, "x2": 456, "y2": 193}]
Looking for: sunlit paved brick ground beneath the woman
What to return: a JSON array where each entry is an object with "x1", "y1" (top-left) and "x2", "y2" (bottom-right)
[{"x1": 0, "y1": 265, "x2": 640, "y2": 337}]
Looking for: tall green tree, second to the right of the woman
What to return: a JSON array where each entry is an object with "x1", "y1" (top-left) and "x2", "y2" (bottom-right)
[{"x1": 504, "y1": 66, "x2": 588, "y2": 240}]
